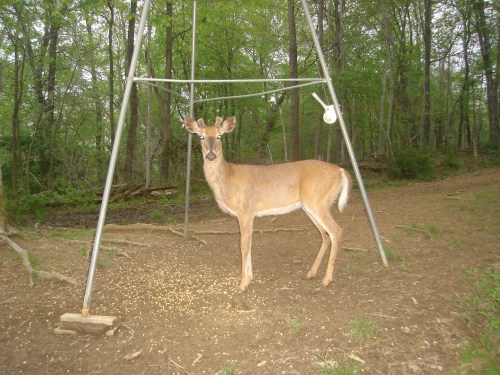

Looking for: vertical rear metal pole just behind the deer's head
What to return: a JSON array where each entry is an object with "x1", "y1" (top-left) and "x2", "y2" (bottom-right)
[{"x1": 184, "y1": 1, "x2": 196, "y2": 238}]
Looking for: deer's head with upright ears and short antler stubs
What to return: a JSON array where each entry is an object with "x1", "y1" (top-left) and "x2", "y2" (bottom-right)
[{"x1": 184, "y1": 116, "x2": 236, "y2": 162}]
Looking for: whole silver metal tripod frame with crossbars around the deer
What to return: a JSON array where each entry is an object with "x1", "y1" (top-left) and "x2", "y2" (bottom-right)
[{"x1": 82, "y1": 0, "x2": 387, "y2": 316}]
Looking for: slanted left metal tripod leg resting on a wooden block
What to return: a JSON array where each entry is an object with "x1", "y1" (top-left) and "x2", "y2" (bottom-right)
[{"x1": 82, "y1": 0, "x2": 150, "y2": 316}]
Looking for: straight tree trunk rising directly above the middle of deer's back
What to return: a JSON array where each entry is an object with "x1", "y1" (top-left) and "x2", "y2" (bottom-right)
[{"x1": 288, "y1": 0, "x2": 299, "y2": 161}]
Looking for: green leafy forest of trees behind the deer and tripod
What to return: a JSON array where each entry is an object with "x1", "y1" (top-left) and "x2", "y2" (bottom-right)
[{"x1": 0, "y1": 0, "x2": 500, "y2": 220}]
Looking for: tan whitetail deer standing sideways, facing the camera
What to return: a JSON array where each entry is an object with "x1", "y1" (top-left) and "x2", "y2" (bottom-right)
[{"x1": 184, "y1": 117, "x2": 351, "y2": 291}]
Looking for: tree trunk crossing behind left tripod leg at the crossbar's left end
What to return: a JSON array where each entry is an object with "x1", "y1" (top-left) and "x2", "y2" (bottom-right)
[{"x1": 124, "y1": 0, "x2": 139, "y2": 183}]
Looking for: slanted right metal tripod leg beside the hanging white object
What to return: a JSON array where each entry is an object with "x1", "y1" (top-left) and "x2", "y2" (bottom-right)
[{"x1": 301, "y1": 0, "x2": 387, "y2": 266}]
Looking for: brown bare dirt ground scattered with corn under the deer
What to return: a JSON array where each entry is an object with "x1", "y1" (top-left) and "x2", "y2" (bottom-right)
[{"x1": 0, "y1": 168, "x2": 500, "y2": 375}]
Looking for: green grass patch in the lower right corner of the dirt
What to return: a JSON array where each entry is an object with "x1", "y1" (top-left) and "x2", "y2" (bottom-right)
[{"x1": 459, "y1": 267, "x2": 500, "y2": 375}]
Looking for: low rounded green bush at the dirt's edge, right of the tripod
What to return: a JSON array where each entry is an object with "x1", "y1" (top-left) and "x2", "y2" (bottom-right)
[{"x1": 385, "y1": 148, "x2": 435, "y2": 180}]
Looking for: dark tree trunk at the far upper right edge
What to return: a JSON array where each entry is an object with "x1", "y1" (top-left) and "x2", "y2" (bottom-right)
[{"x1": 474, "y1": 0, "x2": 500, "y2": 148}]
